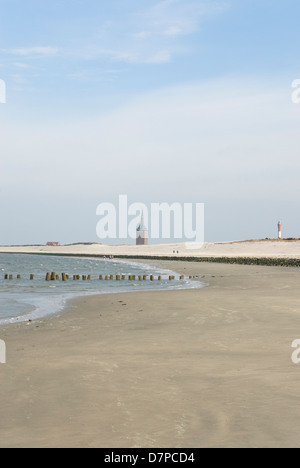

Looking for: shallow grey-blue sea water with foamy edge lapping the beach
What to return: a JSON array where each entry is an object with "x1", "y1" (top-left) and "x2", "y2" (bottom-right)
[{"x1": 0, "y1": 254, "x2": 203, "y2": 325}]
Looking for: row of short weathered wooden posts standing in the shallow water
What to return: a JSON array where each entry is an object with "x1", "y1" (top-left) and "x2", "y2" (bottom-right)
[{"x1": 4, "y1": 272, "x2": 193, "y2": 281}]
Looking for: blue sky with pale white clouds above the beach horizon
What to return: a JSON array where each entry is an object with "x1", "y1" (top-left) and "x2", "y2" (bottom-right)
[{"x1": 0, "y1": 0, "x2": 300, "y2": 245}]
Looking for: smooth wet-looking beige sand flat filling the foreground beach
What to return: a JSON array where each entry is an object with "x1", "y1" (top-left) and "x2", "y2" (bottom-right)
[{"x1": 0, "y1": 262, "x2": 300, "y2": 448}]
